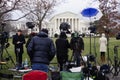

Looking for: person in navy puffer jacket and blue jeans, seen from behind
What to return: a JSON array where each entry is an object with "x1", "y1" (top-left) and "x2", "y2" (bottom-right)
[{"x1": 27, "y1": 29, "x2": 55, "y2": 72}]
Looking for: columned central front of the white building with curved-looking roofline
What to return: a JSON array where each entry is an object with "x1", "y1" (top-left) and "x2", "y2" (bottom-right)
[{"x1": 47, "y1": 12, "x2": 89, "y2": 36}]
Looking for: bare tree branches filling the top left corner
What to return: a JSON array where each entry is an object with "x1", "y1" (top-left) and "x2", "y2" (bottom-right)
[{"x1": 0, "y1": 0, "x2": 29, "y2": 31}]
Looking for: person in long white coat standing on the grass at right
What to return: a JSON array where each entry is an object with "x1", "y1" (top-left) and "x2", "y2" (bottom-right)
[{"x1": 99, "y1": 33, "x2": 107, "y2": 63}]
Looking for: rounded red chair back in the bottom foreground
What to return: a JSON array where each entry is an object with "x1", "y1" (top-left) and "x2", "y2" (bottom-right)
[{"x1": 22, "y1": 70, "x2": 47, "y2": 80}]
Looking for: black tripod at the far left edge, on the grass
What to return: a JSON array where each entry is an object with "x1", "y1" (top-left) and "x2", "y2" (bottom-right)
[{"x1": 0, "y1": 43, "x2": 15, "y2": 67}]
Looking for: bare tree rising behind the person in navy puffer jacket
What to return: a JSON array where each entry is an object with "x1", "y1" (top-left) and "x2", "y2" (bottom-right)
[{"x1": 20, "y1": 0, "x2": 61, "y2": 31}]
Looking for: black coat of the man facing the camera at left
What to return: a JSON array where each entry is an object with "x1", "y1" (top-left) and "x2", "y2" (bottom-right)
[{"x1": 12, "y1": 34, "x2": 25, "y2": 53}]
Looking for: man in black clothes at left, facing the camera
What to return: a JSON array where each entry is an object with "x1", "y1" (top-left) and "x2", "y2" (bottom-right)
[{"x1": 12, "y1": 30, "x2": 25, "y2": 67}]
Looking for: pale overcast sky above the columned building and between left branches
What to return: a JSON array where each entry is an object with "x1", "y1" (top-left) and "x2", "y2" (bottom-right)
[{"x1": 14, "y1": 0, "x2": 101, "y2": 21}]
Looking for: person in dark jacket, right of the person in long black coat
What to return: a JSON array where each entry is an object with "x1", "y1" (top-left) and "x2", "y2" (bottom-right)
[{"x1": 70, "y1": 32, "x2": 84, "y2": 67}]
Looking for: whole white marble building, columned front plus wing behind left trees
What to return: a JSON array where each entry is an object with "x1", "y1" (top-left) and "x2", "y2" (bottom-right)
[{"x1": 11, "y1": 12, "x2": 89, "y2": 37}]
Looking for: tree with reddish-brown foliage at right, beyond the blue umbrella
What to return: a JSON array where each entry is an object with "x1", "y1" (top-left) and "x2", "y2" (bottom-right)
[{"x1": 99, "y1": 0, "x2": 120, "y2": 31}]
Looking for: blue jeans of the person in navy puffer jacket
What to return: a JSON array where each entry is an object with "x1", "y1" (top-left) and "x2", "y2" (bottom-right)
[{"x1": 32, "y1": 63, "x2": 48, "y2": 72}]
